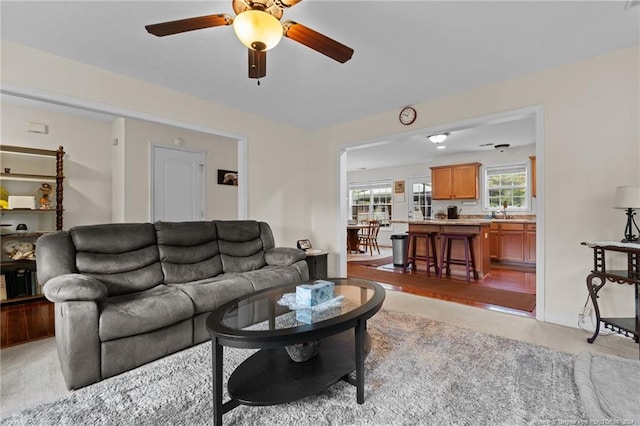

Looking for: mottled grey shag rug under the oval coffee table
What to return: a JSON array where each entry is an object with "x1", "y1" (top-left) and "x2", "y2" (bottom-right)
[{"x1": 2, "y1": 310, "x2": 585, "y2": 426}]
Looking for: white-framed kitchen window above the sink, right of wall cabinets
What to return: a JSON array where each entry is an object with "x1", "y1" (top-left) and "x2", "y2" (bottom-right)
[{"x1": 484, "y1": 164, "x2": 529, "y2": 210}]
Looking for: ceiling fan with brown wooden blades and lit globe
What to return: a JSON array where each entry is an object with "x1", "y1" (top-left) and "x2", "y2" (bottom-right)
[{"x1": 145, "y1": 0, "x2": 353, "y2": 83}]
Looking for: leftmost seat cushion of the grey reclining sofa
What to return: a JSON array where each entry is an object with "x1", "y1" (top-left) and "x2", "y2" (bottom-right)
[{"x1": 98, "y1": 285, "x2": 193, "y2": 342}]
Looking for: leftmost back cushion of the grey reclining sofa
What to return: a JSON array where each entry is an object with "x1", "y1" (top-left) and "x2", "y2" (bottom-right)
[{"x1": 69, "y1": 223, "x2": 163, "y2": 296}]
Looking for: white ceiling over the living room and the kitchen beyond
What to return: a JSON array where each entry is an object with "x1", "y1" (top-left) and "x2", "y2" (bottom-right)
[{"x1": 0, "y1": 0, "x2": 640, "y2": 169}]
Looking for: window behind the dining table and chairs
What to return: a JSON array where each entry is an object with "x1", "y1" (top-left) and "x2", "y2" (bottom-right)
[{"x1": 349, "y1": 180, "x2": 393, "y2": 227}]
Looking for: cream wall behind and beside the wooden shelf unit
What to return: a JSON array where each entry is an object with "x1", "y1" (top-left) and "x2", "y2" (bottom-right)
[{"x1": 1, "y1": 104, "x2": 112, "y2": 229}]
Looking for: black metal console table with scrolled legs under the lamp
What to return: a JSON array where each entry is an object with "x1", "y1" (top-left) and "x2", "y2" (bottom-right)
[{"x1": 582, "y1": 241, "x2": 640, "y2": 358}]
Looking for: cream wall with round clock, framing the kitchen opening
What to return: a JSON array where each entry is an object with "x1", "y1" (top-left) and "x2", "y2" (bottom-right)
[{"x1": 308, "y1": 46, "x2": 640, "y2": 326}]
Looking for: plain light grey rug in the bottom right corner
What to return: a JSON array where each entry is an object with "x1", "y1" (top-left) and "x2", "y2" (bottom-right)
[{"x1": 574, "y1": 352, "x2": 640, "y2": 424}]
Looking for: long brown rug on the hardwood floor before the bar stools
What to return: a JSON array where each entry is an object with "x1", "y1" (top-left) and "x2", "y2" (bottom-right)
[{"x1": 347, "y1": 265, "x2": 536, "y2": 312}]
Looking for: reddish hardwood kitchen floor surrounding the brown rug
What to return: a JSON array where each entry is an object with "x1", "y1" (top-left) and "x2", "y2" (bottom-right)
[{"x1": 347, "y1": 251, "x2": 536, "y2": 318}]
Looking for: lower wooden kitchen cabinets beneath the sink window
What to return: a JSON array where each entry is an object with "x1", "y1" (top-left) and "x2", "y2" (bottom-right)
[{"x1": 489, "y1": 222, "x2": 536, "y2": 263}]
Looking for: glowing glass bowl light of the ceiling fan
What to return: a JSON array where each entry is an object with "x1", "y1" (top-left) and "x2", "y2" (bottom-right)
[{"x1": 233, "y1": 10, "x2": 282, "y2": 51}]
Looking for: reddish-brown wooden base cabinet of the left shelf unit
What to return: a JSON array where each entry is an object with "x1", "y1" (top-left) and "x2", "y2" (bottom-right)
[{"x1": 0, "y1": 299, "x2": 55, "y2": 348}]
